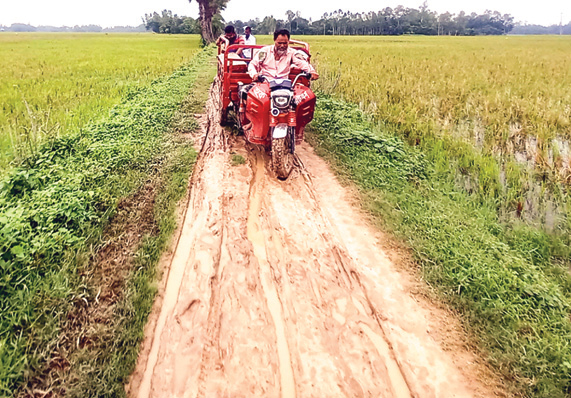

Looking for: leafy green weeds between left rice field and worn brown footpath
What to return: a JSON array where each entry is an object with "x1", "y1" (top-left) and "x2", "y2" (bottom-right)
[{"x1": 0, "y1": 45, "x2": 212, "y2": 396}]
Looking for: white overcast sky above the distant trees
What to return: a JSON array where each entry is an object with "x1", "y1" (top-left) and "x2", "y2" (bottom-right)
[{"x1": 0, "y1": 0, "x2": 571, "y2": 27}]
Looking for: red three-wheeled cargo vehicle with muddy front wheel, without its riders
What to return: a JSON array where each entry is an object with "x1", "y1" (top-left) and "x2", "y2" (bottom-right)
[{"x1": 218, "y1": 40, "x2": 315, "y2": 179}]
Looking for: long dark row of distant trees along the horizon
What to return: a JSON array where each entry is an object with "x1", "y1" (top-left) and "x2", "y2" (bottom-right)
[{"x1": 144, "y1": 2, "x2": 514, "y2": 36}]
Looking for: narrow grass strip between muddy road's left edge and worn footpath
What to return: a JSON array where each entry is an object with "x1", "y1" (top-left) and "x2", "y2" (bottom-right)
[{"x1": 60, "y1": 52, "x2": 216, "y2": 397}]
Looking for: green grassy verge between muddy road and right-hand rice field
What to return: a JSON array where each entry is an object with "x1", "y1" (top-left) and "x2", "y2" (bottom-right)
[{"x1": 309, "y1": 97, "x2": 571, "y2": 397}]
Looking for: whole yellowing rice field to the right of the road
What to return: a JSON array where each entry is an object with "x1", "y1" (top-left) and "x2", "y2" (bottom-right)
[{"x1": 305, "y1": 36, "x2": 571, "y2": 232}]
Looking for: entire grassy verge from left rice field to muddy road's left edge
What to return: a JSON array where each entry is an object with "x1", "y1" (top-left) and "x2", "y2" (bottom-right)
[{"x1": 0, "y1": 45, "x2": 217, "y2": 396}]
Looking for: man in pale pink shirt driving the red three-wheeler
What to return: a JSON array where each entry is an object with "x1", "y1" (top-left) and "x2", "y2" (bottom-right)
[{"x1": 248, "y1": 29, "x2": 319, "y2": 82}]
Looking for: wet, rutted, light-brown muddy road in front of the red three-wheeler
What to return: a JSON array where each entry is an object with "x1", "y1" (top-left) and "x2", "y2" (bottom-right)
[{"x1": 128, "y1": 81, "x2": 489, "y2": 398}]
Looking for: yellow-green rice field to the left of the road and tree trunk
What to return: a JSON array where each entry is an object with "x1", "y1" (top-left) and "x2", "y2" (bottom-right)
[{"x1": 0, "y1": 33, "x2": 200, "y2": 169}]
